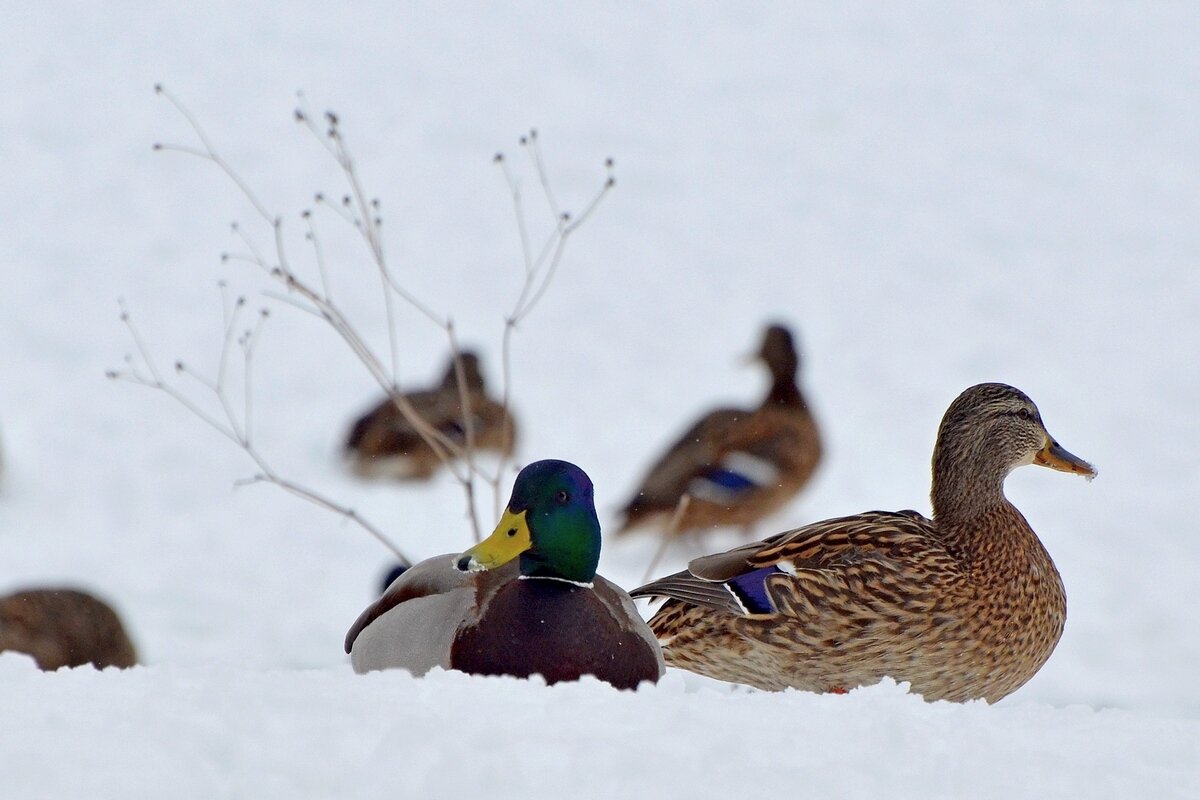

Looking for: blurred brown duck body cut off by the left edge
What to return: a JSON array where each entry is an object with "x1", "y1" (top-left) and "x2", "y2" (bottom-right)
[{"x1": 0, "y1": 589, "x2": 137, "y2": 670}]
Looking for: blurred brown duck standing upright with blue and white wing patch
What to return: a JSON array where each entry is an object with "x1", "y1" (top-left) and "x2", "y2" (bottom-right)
[{"x1": 618, "y1": 325, "x2": 821, "y2": 534}]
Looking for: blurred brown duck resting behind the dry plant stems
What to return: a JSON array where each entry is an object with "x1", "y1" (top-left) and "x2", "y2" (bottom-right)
[{"x1": 346, "y1": 351, "x2": 516, "y2": 480}]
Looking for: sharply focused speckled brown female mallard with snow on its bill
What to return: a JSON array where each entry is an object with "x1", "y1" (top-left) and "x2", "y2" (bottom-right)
[{"x1": 632, "y1": 384, "x2": 1096, "y2": 702}]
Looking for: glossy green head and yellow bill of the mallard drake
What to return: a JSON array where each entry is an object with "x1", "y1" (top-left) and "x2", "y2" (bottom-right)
[{"x1": 455, "y1": 459, "x2": 600, "y2": 584}]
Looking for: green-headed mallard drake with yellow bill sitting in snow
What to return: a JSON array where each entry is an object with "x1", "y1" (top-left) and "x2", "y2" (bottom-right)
[{"x1": 346, "y1": 461, "x2": 664, "y2": 688}]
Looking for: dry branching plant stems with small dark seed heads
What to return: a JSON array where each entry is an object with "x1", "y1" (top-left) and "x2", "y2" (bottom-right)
[{"x1": 113, "y1": 85, "x2": 616, "y2": 563}]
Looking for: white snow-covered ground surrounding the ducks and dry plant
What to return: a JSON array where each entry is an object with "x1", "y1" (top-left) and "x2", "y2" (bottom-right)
[{"x1": 0, "y1": 0, "x2": 1200, "y2": 798}]
